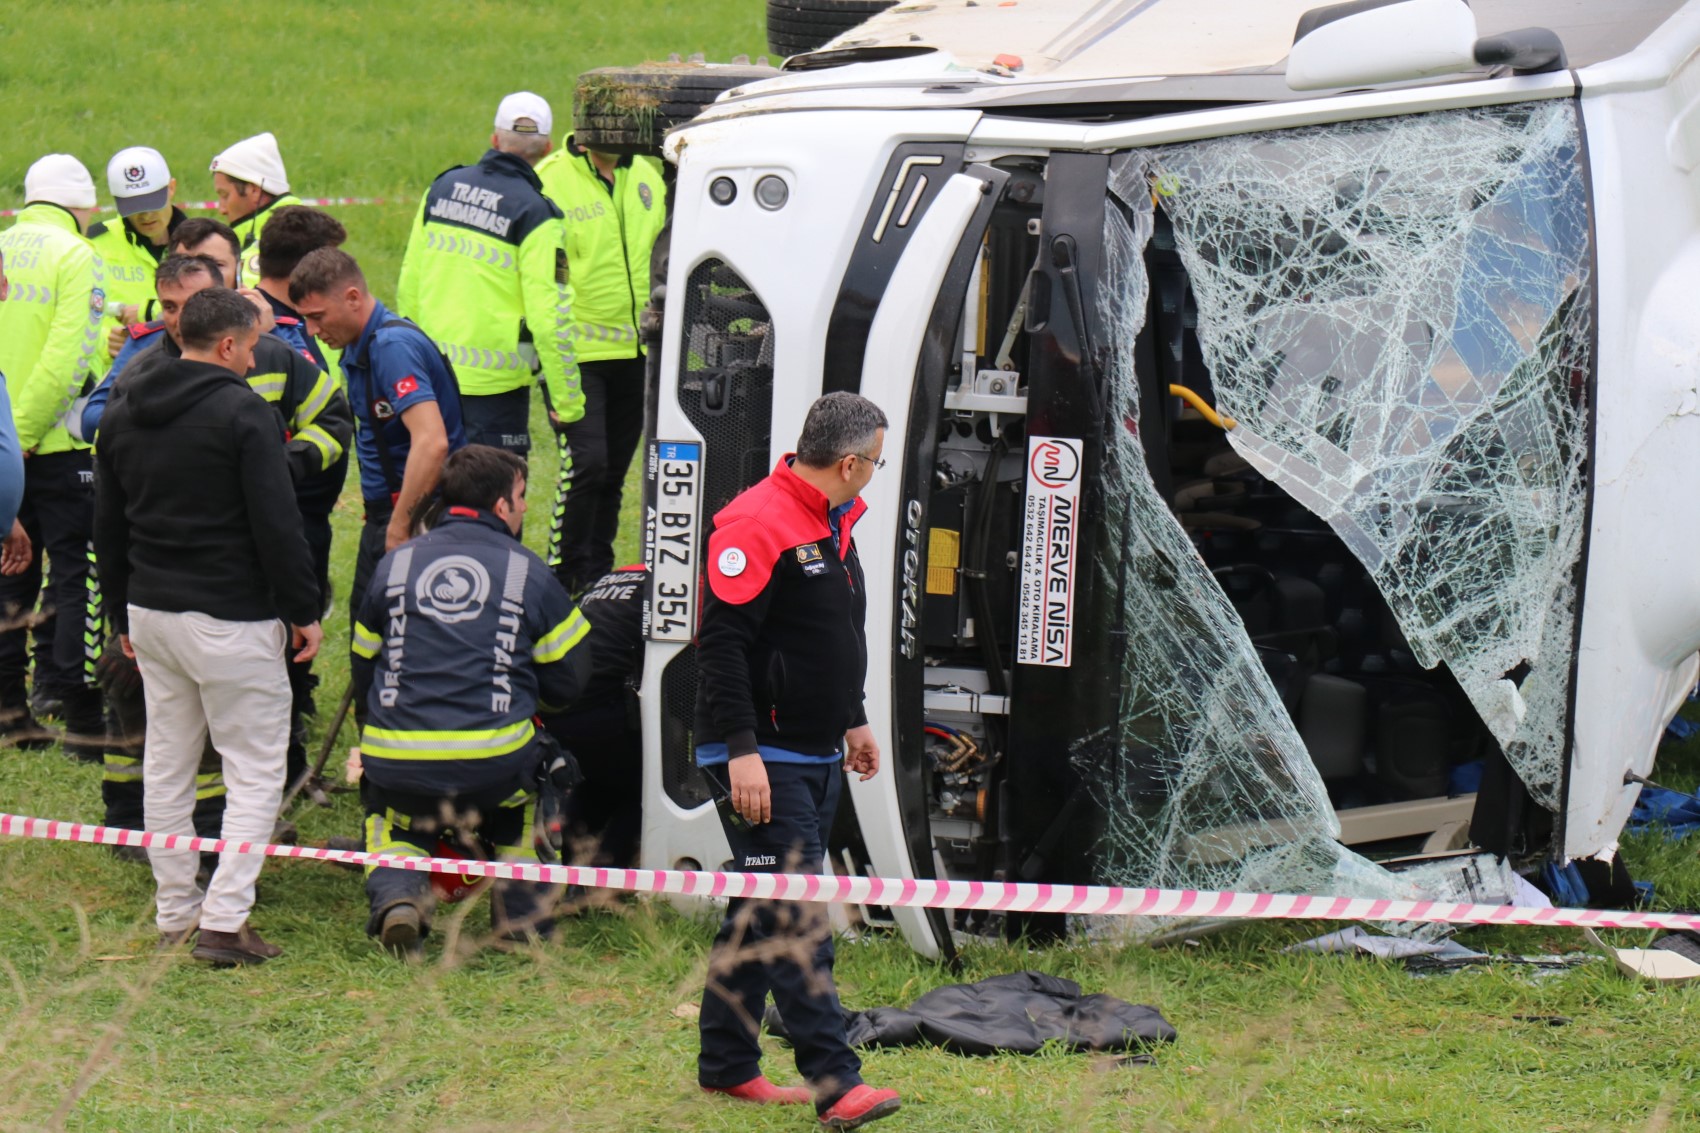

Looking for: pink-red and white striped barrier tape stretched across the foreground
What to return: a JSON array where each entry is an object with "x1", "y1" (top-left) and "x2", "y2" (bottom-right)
[{"x1": 0, "y1": 813, "x2": 1700, "y2": 931}]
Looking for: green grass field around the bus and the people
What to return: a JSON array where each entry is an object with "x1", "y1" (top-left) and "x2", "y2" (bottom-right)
[{"x1": 0, "y1": 0, "x2": 1700, "y2": 1133}]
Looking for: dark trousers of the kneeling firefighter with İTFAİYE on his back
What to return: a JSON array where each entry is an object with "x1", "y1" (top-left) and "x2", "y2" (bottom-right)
[{"x1": 360, "y1": 779, "x2": 559, "y2": 939}]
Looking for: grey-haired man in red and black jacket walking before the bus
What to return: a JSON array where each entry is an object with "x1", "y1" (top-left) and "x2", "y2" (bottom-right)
[{"x1": 695, "y1": 393, "x2": 898, "y2": 1130}]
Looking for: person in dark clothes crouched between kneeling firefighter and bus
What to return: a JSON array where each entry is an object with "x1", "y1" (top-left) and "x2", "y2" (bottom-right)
[{"x1": 542, "y1": 565, "x2": 649, "y2": 869}]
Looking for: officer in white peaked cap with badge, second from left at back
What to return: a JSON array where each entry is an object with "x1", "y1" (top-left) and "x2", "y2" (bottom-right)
[{"x1": 88, "y1": 146, "x2": 189, "y2": 365}]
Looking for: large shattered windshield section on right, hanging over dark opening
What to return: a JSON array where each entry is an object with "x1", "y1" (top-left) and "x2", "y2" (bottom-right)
[{"x1": 1149, "y1": 100, "x2": 1591, "y2": 810}]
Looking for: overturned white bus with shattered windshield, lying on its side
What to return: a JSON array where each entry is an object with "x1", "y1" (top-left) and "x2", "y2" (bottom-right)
[{"x1": 643, "y1": 0, "x2": 1700, "y2": 954}]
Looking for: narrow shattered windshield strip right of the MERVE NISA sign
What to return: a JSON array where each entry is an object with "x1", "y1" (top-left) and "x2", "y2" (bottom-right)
[{"x1": 1073, "y1": 155, "x2": 1411, "y2": 898}]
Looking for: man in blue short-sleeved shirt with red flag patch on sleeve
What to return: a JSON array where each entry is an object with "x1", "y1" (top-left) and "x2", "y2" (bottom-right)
[{"x1": 289, "y1": 248, "x2": 466, "y2": 636}]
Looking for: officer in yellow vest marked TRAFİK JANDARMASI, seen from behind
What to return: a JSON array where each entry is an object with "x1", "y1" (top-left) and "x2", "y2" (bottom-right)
[{"x1": 396, "y1": 90, "x2": 583, "y2": 456}]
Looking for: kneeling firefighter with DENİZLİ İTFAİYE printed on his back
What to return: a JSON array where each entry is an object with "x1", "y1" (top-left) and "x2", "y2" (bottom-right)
[{"x1": 350, "y1": 444, "x2": 590, "y2": 954}]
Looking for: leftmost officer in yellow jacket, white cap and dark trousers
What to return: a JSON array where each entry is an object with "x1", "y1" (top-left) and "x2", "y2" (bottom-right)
[{"x1": 0, "y1": 153, "x2": 107, "y2": 748}]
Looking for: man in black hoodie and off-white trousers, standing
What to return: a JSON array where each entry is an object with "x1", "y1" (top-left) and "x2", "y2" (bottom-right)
[{"x1": 95, "y1": 288, "x2": 321, "y2": 965}]
